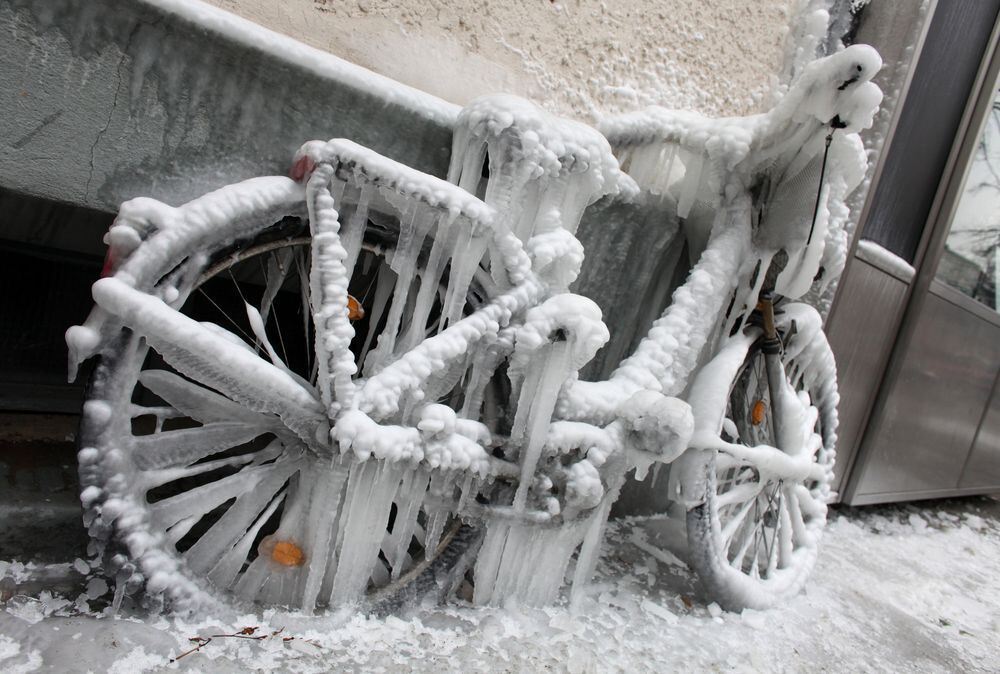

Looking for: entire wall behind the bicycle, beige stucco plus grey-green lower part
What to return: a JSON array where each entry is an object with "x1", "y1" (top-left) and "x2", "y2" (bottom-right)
[{"x1": 0, "y1": 0, "x2": 805, "y2": 220}]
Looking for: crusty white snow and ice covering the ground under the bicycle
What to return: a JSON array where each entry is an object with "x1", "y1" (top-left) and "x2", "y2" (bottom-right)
[{"x1": 0, "y1": 499, "x2": 1000, "y2": 673}]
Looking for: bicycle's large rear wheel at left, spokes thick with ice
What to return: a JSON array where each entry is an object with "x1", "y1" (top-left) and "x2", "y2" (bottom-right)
[{"x1": 74, "y1": 167, "x2": 500, "y2": 611}]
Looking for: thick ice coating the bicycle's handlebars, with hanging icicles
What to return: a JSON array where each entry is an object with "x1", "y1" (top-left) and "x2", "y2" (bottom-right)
[{"x1": 601, "y1": 45, "x2": 882, "y2": 308}]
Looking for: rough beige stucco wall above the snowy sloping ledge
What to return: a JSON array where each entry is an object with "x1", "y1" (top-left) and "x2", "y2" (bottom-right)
[{"x1": 208, "y1": 0, "x2": 796, "y2": 121}]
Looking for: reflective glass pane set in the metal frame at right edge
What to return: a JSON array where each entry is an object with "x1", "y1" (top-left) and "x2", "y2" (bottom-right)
[{"x1": 937, "y1": 86, "x2": 1000, "y2": 310}]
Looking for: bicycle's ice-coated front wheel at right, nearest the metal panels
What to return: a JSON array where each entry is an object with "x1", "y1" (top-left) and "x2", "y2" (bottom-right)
[{"x1": 686, "y1": 305, "x2": 838, "y2": 610}]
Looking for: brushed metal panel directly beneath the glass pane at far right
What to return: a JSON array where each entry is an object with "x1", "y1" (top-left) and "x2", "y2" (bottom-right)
[{"x1": 852, "y1": 293, "x2": 1000, "y2": 502}]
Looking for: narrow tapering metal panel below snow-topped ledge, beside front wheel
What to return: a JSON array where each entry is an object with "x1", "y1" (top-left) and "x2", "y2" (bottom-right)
[{"x1": 827, "y1": 259, "x2": 907, "y2": 491}]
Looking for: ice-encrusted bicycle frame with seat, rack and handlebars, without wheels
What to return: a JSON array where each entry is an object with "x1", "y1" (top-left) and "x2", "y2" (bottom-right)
[{"x1": 67, "y1": 46, "x2": 881, "y2": 610}]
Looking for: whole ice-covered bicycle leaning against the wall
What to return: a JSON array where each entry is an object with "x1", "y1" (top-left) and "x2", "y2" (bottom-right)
[{"x1": 67, "y1": 46, "x2": 881, "y2": 611}]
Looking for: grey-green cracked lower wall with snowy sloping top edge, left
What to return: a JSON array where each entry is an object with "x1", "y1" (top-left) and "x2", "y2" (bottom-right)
[{"x1": 0, "y1": 0, "x2": 456, "y2": 215}]
